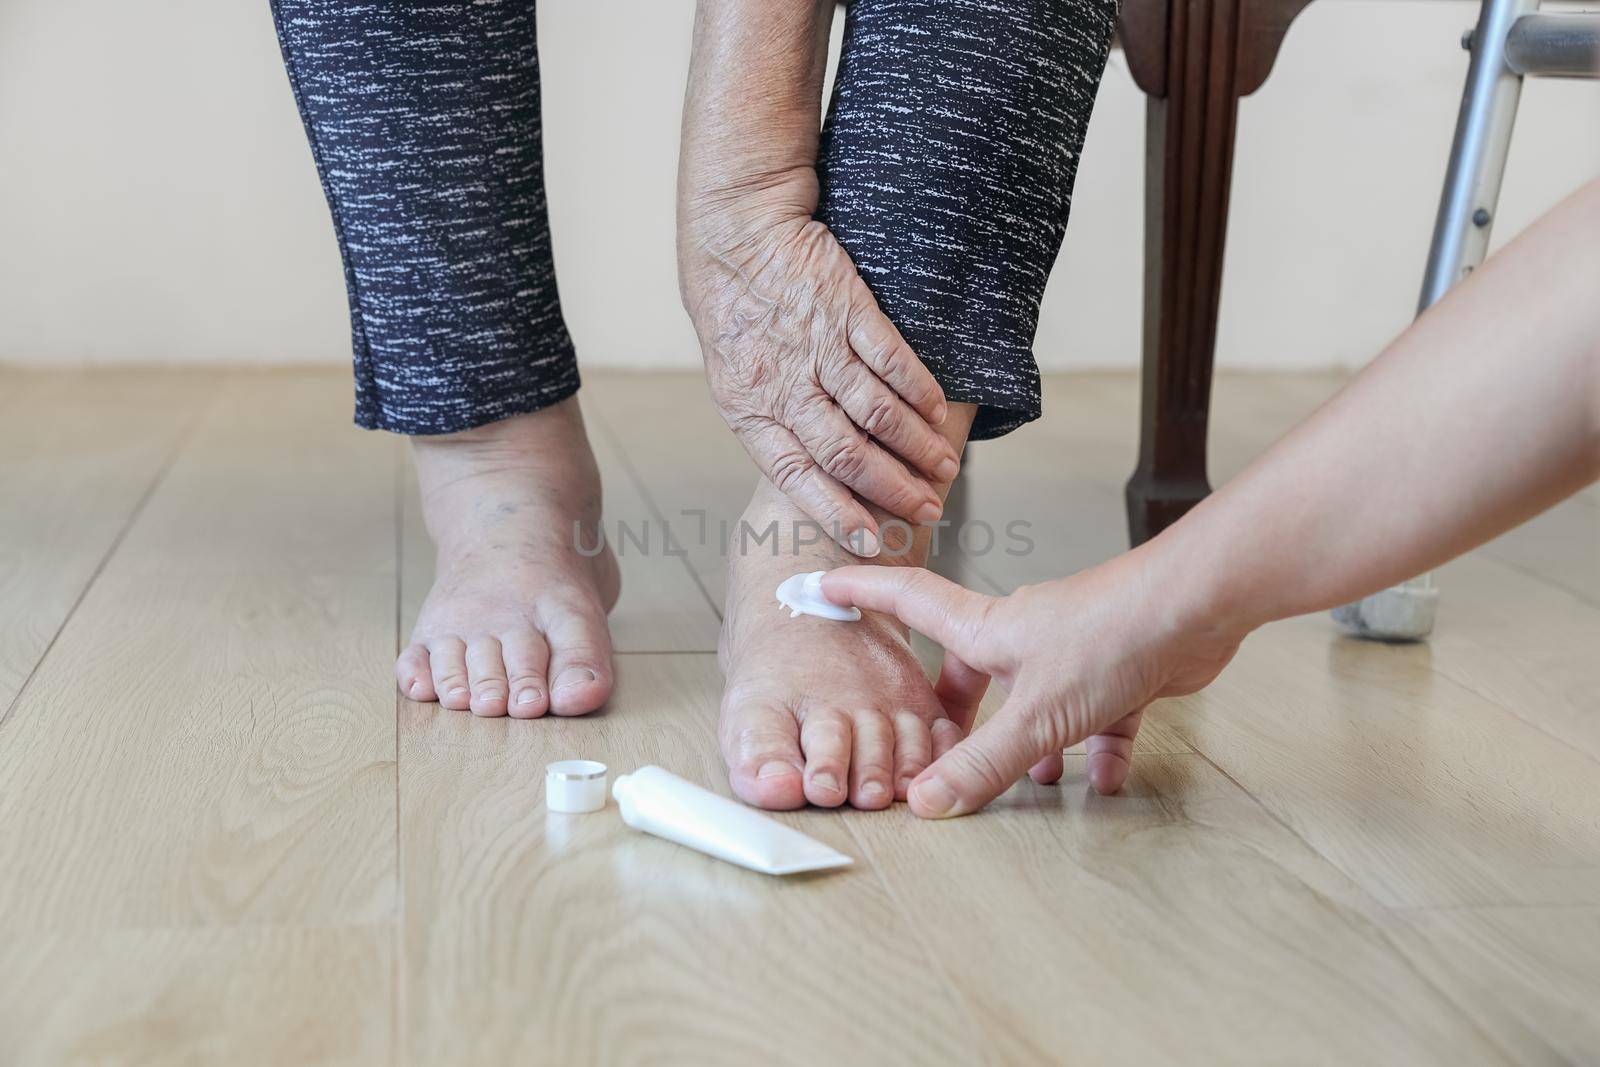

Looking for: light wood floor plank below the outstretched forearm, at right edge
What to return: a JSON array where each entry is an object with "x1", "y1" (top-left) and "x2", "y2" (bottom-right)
[{"x1": 1163, "y1": 616, "x2": 1600, "y2": 907}]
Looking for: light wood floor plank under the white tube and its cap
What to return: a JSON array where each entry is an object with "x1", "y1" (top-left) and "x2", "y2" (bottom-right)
[{"x1": 400, "y1": 656, "x2": 978, "y2": 1064}]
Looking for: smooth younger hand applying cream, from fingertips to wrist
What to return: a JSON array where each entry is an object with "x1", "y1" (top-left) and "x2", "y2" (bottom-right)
[{"x1": 822, "y1": 553, "x2": 1243, "y2": 819}]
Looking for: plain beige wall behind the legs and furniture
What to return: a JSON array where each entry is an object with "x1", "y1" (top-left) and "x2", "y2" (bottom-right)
[{"x1": 0, "y1": 0, "x2": 1600, "y2": 368}]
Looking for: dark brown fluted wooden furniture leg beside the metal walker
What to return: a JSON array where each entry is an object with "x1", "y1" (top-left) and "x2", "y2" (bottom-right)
[{"x1": 1118, "y1": 0, "x2": 1310, "y2": 544}]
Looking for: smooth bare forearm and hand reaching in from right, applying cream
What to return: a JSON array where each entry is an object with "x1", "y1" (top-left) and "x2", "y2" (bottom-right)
[{"x1": 822, "y1": 181, "x2": 1600, "y2": 816}]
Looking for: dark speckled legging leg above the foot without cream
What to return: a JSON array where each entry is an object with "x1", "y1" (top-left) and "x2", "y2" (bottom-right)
[{"x1": 272, "y1": 0, "x2": 578, "y2": 434}]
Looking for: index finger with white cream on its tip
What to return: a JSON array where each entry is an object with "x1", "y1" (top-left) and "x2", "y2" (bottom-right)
[{"x1": 822, "y1": 566, "x2": 995, "y2": 667}]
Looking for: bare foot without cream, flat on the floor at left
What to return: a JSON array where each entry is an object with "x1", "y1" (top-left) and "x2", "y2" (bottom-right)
[{"x1": 395, "y1": 398, "x2": 619, "y2": 718}]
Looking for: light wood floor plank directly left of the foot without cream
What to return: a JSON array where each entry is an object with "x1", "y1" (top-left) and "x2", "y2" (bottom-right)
[{"x1": 0, "y1": 376, "x2": 395, "y2": 933}]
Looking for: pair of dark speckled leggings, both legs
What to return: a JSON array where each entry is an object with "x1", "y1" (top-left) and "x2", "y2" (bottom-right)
[{"x1": 272, "y1": 0, "x2": 1117, "y2": 438}]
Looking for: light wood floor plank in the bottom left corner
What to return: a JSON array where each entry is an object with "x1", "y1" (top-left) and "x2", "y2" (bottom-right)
[{"x1": 0, "y1": 925, "x2": 394, "y2": 1067}]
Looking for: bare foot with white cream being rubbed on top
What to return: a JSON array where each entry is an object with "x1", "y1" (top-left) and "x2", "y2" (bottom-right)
[{"x1": 717, "y1": 405, "x2": 978, "y2": 808}]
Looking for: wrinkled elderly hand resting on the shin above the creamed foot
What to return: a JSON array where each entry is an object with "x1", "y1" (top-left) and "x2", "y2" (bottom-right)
[{"x1": 682, "y1": 216, "x2": 960, "y2": 555}]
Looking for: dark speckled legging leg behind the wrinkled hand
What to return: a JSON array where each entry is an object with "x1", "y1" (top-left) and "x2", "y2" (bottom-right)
[{"x1": 818, "y1": 0, "x2": 1117, "y2": 440}]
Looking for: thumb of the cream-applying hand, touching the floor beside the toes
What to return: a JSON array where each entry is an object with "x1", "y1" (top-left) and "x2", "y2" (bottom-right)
[{"x1": 906, "y1": 699, "x2": 1064, "y2": 819}]
